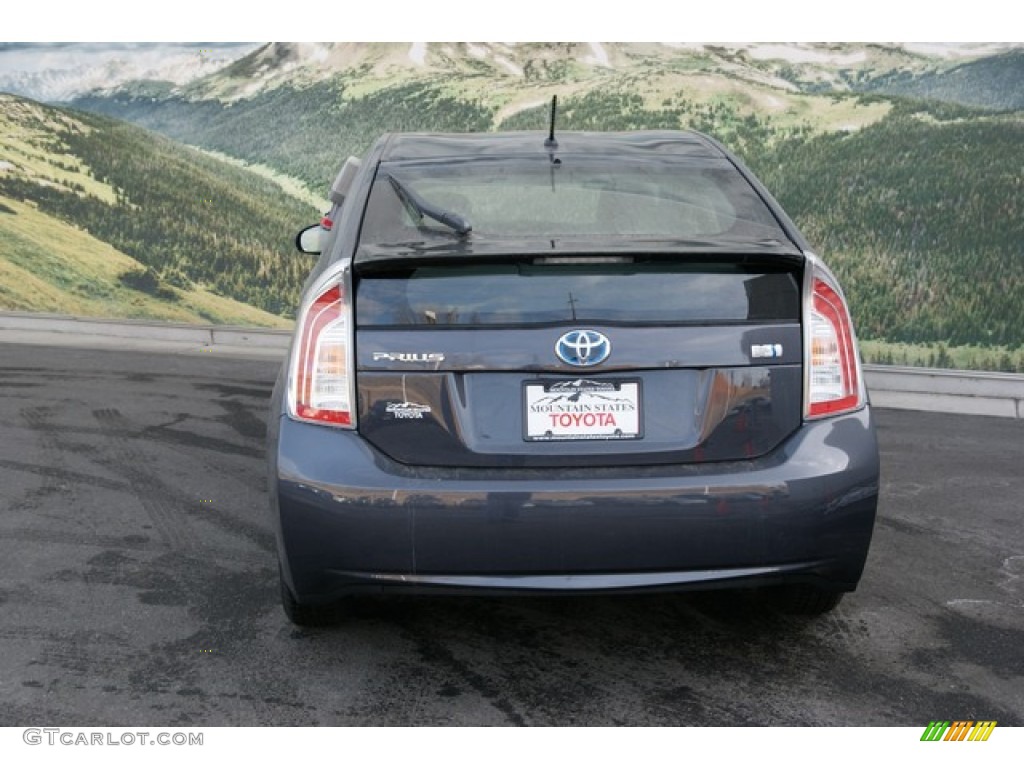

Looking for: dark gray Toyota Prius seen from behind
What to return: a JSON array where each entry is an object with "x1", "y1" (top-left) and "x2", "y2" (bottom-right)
[{"x1": 268, "y1": 131, "x2": 879, "y2": 625}]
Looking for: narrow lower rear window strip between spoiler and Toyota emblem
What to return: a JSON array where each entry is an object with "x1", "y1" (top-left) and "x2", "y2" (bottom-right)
[{"x1": 355, "y1": 261, "x2": 800, "y2": 326}]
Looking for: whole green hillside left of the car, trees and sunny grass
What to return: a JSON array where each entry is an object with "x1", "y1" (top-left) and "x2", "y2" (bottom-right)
[{"x1": 0, "y1": 94, "x2": 318, "y2": 325}]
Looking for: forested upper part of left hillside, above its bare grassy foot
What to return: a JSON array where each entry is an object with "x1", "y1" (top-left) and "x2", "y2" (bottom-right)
[{"x1": 0, "y1": 96, "x2": 318, "y2": 315}]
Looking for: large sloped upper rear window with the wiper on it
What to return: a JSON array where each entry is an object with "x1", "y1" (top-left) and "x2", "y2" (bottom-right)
[{"x1": 359, "y1": 156, "x2": 786, "y2": 246}]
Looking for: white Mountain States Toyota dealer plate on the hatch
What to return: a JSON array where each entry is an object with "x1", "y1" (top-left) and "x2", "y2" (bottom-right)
[{"x1": 523, "y1": 379, "x2": 643, "y2": 440}]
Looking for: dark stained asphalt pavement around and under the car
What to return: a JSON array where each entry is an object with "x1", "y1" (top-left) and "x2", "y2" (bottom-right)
[{"x1": 0, "y1": 344, "x2": 1024, "y2": 728}]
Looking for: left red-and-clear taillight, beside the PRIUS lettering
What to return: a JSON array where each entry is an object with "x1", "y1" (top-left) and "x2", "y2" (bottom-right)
[{"x1": 289, "y1": 285, "x2": 355, "y2": 428}]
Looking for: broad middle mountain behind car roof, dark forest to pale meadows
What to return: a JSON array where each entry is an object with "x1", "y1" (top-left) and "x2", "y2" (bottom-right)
[{"x1": 73, "y1": 43, "x2": 1024, "y2": 189}]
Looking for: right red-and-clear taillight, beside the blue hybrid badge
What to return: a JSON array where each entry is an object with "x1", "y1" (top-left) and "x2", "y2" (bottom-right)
[{"x1": 804, "y1": 267, "x2": 864, "y2": 419}]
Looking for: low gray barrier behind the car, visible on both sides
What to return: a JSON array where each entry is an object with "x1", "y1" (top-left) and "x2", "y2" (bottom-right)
[{"x1": 0, "y1": 312, "x2": 1024, "y2": 419}]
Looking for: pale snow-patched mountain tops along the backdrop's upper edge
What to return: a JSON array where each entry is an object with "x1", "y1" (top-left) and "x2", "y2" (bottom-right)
[{"x1": 0, "y1": 43, "x2": 1022, "y2": 101}]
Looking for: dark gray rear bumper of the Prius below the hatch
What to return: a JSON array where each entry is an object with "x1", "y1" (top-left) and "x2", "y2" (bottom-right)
[{"x1": 268, "y1": 409, "x2": 879, "y2": 602}]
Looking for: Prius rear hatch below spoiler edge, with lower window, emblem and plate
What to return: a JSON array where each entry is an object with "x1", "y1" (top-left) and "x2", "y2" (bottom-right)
[{"x1": 354, "y1": 253, "x2": 803, "y2": 468}]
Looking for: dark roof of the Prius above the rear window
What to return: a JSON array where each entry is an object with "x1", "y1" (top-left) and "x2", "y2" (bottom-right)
[{"x1": 380, "y1": 131, "x2": 725, "y2": 162}]
